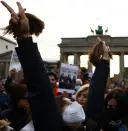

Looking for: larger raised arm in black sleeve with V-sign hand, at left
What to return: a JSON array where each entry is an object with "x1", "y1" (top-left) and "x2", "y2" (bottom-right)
[{"x1": 2, "y1": 2, "x2": 61, "y2": 131}]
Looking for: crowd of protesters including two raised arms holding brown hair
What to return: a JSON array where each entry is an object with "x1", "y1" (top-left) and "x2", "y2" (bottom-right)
[{"x1": 0, "y1": 1, "x2": 128, "y2": 131}]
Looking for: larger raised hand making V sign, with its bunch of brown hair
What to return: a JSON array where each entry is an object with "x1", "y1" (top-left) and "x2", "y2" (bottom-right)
[{"x1": 1, "y1": 1, "x2": 44, "y2": 38}]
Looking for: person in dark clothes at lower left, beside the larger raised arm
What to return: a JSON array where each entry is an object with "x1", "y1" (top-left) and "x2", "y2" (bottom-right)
[{"x1": 1, "y1": 80, "x2": 31, "y2": 131}]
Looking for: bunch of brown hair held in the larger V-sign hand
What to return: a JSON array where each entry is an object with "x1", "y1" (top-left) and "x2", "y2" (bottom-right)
[{"x1": 4, "y1": 13, "x2": 44, "y2": 38}]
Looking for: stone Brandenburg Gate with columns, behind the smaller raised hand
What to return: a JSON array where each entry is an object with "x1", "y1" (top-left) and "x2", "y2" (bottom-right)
[{"x1": 58, "y1": 35, "x2": 128, "y2": 78}]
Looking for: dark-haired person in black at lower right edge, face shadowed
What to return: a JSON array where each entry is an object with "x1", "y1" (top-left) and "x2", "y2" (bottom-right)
[{"x1": 101, "y1": 88, "x2": 128, "y2": 131}]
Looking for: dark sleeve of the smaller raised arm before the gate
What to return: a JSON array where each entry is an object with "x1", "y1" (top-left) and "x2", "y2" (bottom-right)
[{"x1": 86, "y1": 60, "x2": 109, "y2": 120}]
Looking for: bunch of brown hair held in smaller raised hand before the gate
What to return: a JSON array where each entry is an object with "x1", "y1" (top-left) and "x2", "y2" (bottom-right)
[{"x1": 89, "y1": 38, "x2": 112, "y2": 65}]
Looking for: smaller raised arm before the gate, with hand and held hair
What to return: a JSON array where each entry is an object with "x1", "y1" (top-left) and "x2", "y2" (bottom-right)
[{"x1": 86, "y1": 38, "x2": 111, "y2": 121}]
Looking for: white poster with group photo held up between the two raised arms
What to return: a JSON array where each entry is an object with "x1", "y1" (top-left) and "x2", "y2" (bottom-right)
[{"x1": 59, "y1": 63, "x2": 78, "y2": 93}]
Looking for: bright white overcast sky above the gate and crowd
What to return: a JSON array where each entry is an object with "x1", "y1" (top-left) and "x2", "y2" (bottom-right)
[{"x1": 0, "y1": 0, "x2": 128, "y2": 60}]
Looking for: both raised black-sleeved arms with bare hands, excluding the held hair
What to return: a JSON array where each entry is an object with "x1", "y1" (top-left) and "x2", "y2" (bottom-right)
[{"x1": 2, "y1": 2, "x2": 112, "y2": 131}]
